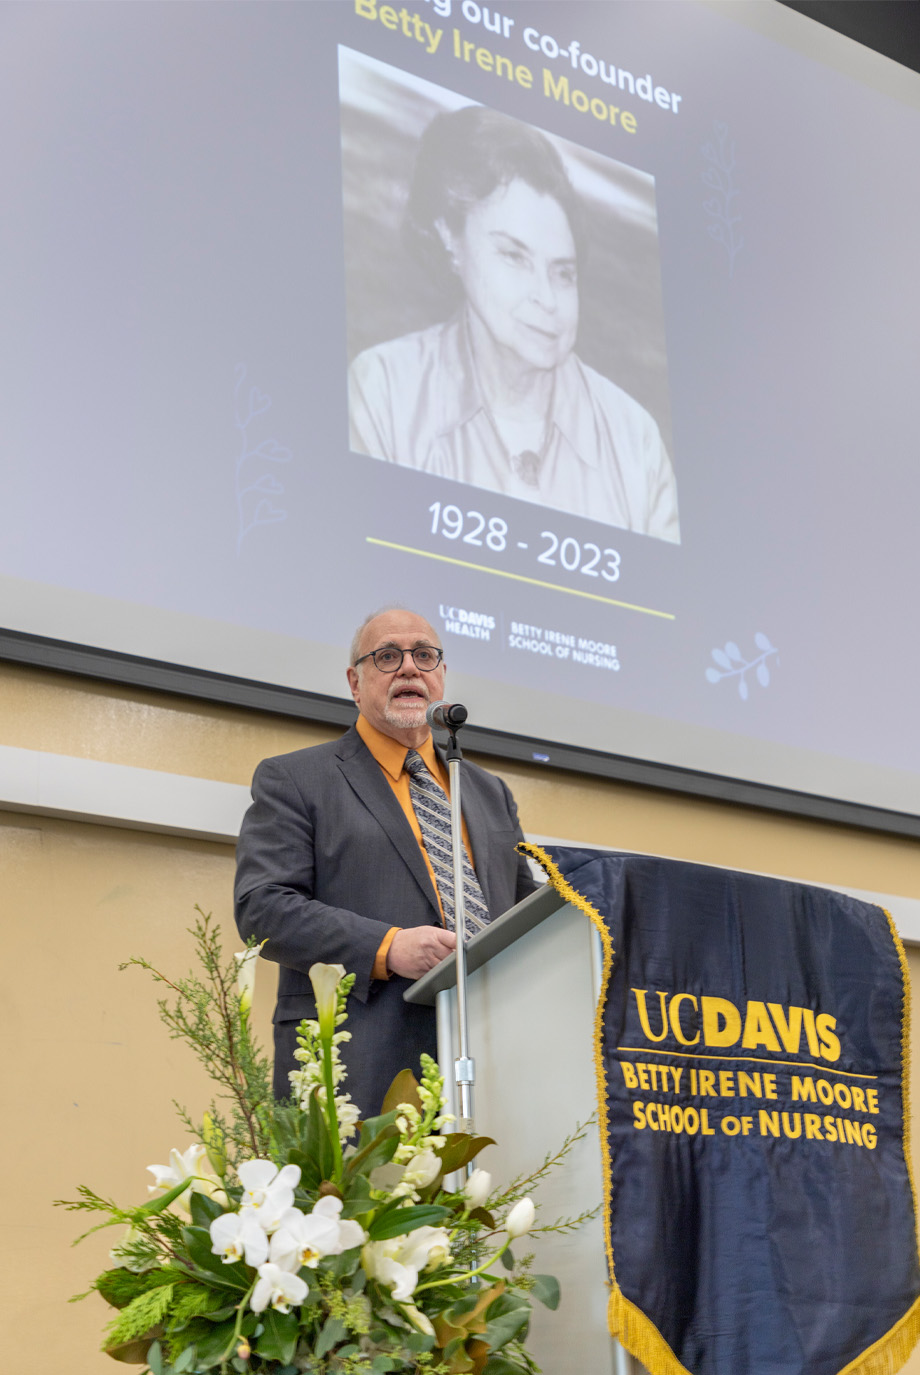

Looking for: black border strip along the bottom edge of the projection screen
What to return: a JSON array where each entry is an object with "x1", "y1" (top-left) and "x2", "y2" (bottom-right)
[{"x1": 0, "y1": 628, "x2": 920, "y2": 839}]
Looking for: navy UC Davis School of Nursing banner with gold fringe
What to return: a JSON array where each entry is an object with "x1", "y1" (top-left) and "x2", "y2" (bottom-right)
[{"x1": 529, "y1": 847, "x2": 920, "y2": 1375}]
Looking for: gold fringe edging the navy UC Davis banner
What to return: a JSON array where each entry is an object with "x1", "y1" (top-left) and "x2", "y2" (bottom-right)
[{"x1": 517, "y1": 840, "x2": 920, "y2": 1375}]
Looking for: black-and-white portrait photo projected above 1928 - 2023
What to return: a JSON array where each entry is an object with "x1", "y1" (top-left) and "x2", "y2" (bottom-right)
[{"x1": 344, "y1": 48, "x2": 679, "y2": 542}]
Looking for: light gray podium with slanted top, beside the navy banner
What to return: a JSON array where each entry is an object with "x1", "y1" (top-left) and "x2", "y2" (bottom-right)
[{"x1": 404, "y1": 886, "x2": 641, "y2": 1375}]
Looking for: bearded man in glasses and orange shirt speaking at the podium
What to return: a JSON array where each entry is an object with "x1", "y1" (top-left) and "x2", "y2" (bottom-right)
[{"x1": 235, "y1": 609, "x2": 536, "y2": 1117}]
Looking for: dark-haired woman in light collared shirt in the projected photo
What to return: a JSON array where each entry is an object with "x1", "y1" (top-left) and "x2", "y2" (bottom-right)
[{"x1": 349, "y1": 106, "x2": 681, "y2": 542}]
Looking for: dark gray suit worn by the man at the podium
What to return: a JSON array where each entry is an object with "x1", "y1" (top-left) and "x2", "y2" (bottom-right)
[{"x1": 235, "y1": 726, "x2": 535, "y2": 1115}]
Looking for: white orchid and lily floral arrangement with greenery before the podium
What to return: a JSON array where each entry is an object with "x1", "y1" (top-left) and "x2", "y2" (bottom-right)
[{"x1": 59, "y1": 914, "x2": 583, "y2": 1375}]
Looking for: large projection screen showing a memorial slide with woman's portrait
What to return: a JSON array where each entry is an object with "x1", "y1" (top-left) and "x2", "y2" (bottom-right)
[{"x1": 0, "y1": 0, "x2": 920, "y2": 835}]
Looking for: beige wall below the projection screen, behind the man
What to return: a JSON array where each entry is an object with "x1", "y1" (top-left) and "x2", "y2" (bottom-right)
[{"x1": 0, "y1": 664, "x2": 920, "y2": 1375}]
